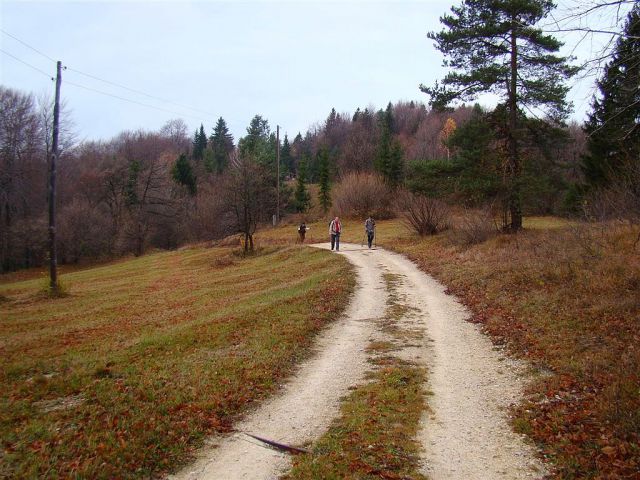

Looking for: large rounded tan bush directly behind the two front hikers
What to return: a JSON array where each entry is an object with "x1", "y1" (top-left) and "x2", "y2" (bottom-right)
[{"x1": 332, "y1": 172, "x2": 394, "y2": 219}]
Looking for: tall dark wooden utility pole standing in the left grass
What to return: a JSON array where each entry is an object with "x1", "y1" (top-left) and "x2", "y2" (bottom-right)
[{"x1": 49, "y1": 61, "x2": 62, "y2": 293}]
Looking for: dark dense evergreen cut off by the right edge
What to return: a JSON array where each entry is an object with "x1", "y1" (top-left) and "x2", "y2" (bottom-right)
[{"x1": 583, "y1": 4, "x2": 640, "y2": 186}]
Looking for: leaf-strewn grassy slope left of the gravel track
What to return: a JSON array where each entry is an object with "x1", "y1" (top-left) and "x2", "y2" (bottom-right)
[{"x1": 0, "y1": 247, "x2": 353, "y2": 478}]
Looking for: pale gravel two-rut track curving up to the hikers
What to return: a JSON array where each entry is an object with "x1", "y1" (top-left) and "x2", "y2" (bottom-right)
[{"x1": 170, "y1": 244, "x2": 545, "y2": 480}]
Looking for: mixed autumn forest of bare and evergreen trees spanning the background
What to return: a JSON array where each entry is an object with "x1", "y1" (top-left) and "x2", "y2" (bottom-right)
[{"x1": 0, "y1": 2, "x2": 640, "y2": 272}]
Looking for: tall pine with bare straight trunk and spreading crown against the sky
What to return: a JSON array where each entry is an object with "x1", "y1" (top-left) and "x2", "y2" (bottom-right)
[{"x1": 420, "y1": 0, "x2": 577, "y2": 231}]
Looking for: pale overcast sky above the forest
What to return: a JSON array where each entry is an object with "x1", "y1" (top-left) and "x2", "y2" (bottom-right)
[{"x1": 0, "y1": 0, "x2": 624, "y2": 140}]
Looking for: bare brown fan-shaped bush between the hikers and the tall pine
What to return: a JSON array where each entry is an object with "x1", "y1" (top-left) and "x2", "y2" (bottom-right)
[{"x1": 397, "y1": 192, "x2": 451, "y2": 236}]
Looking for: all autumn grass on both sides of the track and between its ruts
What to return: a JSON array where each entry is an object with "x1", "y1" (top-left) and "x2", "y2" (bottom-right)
[{"x1": 0, "y1": 218, "x2": 640, "y2": 479}]
